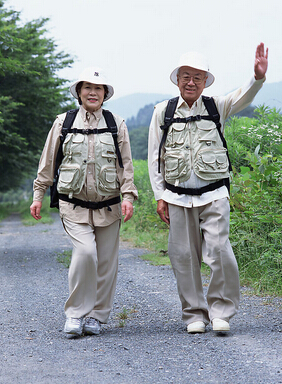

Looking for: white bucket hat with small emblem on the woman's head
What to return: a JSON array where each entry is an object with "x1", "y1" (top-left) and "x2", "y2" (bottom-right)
[{"x1": 70, "y1": 67, "x2": 114, "y2": 101}]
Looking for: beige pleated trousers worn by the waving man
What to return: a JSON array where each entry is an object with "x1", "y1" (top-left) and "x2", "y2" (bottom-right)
[{"x1": 168, "y1": 198, "x2": 240, "y2": 324}]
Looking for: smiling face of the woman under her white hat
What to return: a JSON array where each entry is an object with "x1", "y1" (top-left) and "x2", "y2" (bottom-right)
[{"x1": 79, "y1": 81, "x2": 105, "y2": 113}]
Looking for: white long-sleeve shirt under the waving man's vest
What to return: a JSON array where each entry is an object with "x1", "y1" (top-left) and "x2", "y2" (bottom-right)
[{"x1": 148, "y1": 77, "x2": 265, "y2": 208}]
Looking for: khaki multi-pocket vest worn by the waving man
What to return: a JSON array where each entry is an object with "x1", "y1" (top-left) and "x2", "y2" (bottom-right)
[{"x1": 164, "y1": 120, "x2": 229, "y2": 186}]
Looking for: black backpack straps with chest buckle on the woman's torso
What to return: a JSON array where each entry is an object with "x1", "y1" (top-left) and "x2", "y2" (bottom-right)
[{"x1": 50, "y1": 109, "x2": 123, "y2": 209}]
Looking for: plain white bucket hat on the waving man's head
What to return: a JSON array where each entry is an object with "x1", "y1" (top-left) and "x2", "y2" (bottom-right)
[{"x1": 170, "y1": 52, "x2": 215, "y2": 88}]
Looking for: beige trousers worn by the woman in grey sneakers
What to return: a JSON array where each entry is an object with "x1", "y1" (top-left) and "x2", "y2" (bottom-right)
[{"x1": 63, "y1": 219, "x2": 120, "y2": 323}]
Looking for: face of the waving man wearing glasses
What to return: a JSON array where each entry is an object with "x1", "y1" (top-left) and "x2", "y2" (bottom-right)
[{"x1": 177, "y1": 67, "x2": 207, "y2": 108}]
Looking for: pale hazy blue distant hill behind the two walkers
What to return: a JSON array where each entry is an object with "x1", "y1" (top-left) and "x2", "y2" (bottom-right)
[{"x1": 105, "y1": 82, "x2": 282, "y2": 126}]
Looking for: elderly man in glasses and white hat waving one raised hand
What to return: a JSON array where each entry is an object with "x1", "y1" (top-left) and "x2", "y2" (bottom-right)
[{"x1": 148, "y1": 43, "x2": 268, "y2": 333}]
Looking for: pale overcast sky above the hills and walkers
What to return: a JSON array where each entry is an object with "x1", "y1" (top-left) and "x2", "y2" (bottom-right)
[{"x1": 4, "y1": 0, "x2": 282, "y2": 99}]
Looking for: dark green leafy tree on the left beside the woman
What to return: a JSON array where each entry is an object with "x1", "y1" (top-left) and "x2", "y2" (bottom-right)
[{"x1": 0, "y1": 0, "x2": 73, "y2": 192}]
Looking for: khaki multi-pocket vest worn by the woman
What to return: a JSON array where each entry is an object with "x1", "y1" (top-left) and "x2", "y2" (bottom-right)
[{"x1": 57, "y1": 113, "x2": 120, "y2": 198}]
